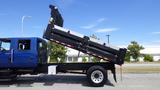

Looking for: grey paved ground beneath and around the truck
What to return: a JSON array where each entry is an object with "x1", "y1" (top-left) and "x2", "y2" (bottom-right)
[{"x1": 0, "y1": 73, "x2": 160, "y2": 90}]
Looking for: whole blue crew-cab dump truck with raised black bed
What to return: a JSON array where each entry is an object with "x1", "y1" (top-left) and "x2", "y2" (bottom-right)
[{"x1": 0, "y1": 5, "x2": 126, "y2": 87}]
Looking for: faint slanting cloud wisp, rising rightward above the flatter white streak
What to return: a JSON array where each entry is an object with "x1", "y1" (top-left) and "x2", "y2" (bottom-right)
[{"x1": 82, "y1": 18, "x2": 106, "y2": 29}]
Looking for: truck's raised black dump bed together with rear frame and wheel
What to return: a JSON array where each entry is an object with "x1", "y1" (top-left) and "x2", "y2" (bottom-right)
[{"x1": 43, "y1": 5, "x2": 126, "y2": 86}]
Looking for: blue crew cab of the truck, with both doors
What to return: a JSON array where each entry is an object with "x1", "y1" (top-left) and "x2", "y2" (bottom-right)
[{"x1": 0, "y1": 37, "x2": 47, "y2": 69}]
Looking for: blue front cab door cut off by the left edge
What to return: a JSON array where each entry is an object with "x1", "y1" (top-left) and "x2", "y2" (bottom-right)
[{"x1": 0, "y1": 39, "x2": 12, "y2": 68}]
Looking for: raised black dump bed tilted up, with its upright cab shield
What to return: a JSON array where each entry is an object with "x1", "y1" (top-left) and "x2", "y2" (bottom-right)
[{"x1": 43, "y1": 5, "x2": 126, "y2": 65}]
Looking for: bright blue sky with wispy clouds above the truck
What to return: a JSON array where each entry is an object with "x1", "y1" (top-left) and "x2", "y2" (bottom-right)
[{"x1": 0, "y1": 0, "x2": 160, "y2": 46}]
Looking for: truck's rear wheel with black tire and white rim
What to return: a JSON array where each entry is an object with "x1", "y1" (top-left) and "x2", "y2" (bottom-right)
[{"x1": 87, "y1": 66, "x2": 107, "y2": 87}]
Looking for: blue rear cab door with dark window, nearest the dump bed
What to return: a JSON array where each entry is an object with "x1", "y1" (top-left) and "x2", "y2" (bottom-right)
[{"x1": 12, "y1": 39, "x2": 36, "y2": 68}]
